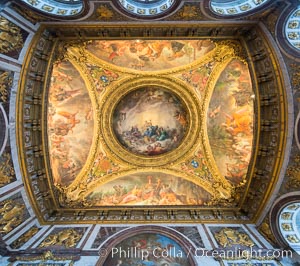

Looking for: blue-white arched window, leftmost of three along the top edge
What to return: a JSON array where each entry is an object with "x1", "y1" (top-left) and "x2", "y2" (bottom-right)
[{"x1": 21, "y1": 0, "x2": 83, "y2": 17}]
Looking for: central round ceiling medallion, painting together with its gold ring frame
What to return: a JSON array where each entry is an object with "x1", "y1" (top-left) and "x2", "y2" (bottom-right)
[{"x1": 100, "y1": 77, "x2": 200, "y2": 166}]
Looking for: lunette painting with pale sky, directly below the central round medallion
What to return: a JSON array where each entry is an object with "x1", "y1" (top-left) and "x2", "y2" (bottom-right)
[{"x1": 88, "y1": 172, "x2": 211, "y2": 206}]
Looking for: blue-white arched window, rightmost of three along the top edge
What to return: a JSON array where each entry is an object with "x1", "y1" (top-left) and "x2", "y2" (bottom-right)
[{"x1": 210, "y1": 0, "x2": 270, "y2": 16}]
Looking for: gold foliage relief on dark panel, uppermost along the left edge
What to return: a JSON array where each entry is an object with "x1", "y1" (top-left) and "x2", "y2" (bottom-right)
[{"x1": 0, "y1": 16, "x2": 23, "y2": 53}]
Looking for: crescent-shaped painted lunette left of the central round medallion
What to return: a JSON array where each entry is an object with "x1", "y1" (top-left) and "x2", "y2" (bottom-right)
[{"x1": 47, "y1": 61, "x2": 94, "y2": 185}]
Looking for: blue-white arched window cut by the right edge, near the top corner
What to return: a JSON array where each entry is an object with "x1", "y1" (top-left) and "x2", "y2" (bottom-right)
[{"x1": 285, "y1": 5, "x2": 300, "y2": 50}]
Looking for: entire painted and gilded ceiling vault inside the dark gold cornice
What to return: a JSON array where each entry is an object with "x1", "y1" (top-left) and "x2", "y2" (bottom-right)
[{"x1": 45, "y1": 39, "x2": 254, "y2": 207}]
